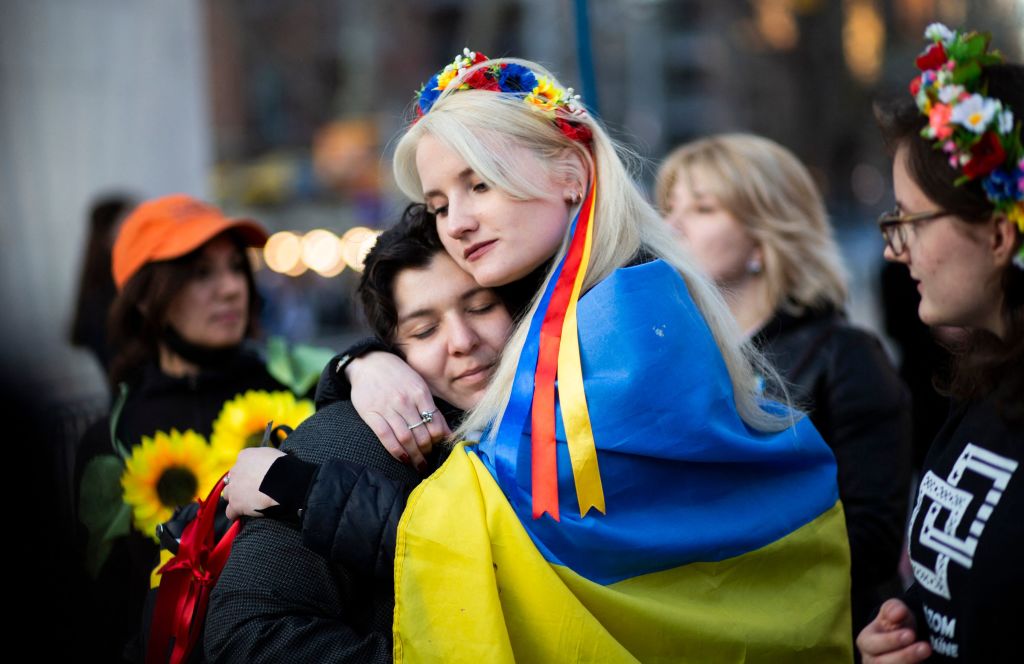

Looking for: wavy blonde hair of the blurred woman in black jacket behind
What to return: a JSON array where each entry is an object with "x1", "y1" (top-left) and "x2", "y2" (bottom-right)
[{"x1": 655, "y1": 133, "x2": 847, "y2": 315}]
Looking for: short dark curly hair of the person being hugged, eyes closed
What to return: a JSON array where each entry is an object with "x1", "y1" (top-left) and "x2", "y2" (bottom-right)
[{"x1": 357, "y1": 203, "x2": 444, "y2": 344}]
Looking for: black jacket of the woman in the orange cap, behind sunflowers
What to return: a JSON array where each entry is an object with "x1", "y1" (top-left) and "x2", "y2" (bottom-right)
[{"x1": 75, "y1": 350, "x2": 285, "y2": 662}]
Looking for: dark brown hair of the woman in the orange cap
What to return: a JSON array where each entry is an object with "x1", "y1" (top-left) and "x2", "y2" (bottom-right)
[{"x1": 108, "y1": 232, "x2": 261, "y2": 386}]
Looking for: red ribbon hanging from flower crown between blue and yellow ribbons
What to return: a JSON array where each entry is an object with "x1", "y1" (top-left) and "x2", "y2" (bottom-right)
[{"x1": 530, "y1": 186, "x2": 595, "y2": 521}]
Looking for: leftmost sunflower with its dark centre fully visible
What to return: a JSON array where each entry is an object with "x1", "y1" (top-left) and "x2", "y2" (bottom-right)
[{"x1": 121, "y1": 429, "x2": 226, "y2": 540}]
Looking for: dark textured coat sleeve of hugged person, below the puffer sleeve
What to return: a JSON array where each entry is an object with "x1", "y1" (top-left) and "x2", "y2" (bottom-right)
[{"x1": 204, "y1": 518, "x2": 391, "y2": 663}]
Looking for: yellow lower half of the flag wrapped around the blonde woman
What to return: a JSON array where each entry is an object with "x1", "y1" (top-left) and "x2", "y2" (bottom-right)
[{"x1": 394, "y1": 446, "x2": 852, "y2": 664}]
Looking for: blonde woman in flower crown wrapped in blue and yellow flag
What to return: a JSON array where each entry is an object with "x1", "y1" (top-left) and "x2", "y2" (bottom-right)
[{"x1": 232, "y1": 50, "x2": 851, "y2": 662}]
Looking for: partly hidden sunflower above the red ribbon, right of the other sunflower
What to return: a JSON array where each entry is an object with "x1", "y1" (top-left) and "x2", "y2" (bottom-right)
[{"x1": 210, "y1": 389, "x2": 313, "y2": 466}]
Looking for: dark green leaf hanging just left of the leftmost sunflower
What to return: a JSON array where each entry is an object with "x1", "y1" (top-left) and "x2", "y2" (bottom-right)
[{"x1": 78, "y1": 454, "x2": 131, "y2": 576}]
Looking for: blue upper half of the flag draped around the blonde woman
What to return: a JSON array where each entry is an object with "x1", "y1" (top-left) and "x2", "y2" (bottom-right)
[{"x1": 470, "y1": 260, "x2": 838, "y2": 584}]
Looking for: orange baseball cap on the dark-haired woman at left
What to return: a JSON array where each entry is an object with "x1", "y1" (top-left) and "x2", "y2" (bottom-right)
[{"x1": 112, "y1": 194, "x2": 267, "y2": 290}]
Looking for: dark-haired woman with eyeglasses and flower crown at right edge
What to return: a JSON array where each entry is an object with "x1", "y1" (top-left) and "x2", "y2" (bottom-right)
[{"x1": 857, "y1": 24, "x2": 1024, "y2": 664}]
